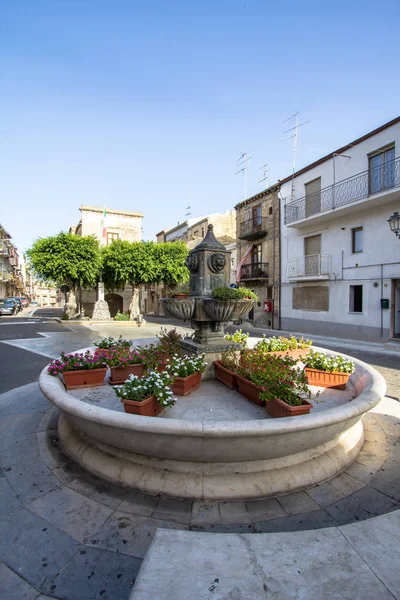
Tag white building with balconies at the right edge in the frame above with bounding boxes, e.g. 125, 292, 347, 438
280, 117, 400, 341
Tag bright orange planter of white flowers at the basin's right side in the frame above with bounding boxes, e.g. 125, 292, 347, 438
304, 352, 354, 390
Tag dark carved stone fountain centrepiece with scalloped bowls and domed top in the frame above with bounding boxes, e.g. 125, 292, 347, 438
161, 225, 253, 379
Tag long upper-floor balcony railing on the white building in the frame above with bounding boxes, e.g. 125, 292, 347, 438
285, 157, 400, 225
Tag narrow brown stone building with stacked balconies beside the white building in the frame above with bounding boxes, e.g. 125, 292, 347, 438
235, 185, 280, 329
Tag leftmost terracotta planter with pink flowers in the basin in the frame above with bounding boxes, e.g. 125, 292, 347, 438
47, 350, 107, 390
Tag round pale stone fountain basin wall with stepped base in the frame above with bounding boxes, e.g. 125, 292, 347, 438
39, 348, 386, 500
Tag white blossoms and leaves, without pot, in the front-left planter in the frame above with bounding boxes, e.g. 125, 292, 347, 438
114, 371, 176, 408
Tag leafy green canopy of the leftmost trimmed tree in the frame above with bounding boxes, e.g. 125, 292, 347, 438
26, 232, 101, 289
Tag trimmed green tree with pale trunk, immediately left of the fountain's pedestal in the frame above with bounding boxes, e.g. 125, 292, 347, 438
101, 240, 189, 321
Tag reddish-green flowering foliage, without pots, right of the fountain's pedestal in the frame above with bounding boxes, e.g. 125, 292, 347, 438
235, 350, 311, 406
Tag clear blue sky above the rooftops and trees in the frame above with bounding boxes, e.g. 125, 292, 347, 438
0, 0, 400, 250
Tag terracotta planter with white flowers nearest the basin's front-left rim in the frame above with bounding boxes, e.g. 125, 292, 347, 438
114, 371, 175, 417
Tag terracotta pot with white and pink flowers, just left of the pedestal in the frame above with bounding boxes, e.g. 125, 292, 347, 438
166, 354, 207, 396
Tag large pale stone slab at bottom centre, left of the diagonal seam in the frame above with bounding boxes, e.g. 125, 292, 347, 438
130, 528, 394, 600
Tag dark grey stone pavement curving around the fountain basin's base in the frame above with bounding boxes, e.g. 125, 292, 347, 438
0, 383, 400, 600
